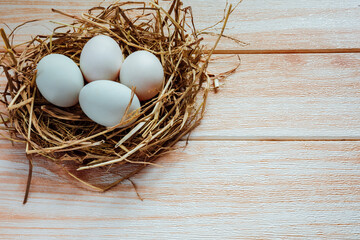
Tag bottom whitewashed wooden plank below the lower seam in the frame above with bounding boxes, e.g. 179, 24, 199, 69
0, 141, 360, 239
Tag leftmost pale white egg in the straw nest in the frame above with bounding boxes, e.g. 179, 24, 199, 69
36, 54, 84, 107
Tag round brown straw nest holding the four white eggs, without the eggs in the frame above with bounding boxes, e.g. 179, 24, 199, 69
1, 0, 233, 201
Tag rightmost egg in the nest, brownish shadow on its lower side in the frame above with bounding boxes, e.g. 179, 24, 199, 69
119, 51, 164, 101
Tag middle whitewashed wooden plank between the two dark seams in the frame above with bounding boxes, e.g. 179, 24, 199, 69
191, 54, 360, 140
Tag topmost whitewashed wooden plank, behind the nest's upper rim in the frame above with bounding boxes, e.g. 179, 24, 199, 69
0, 0, 360, 50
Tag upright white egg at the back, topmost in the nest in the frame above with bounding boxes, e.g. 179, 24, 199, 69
80, 35, 124, 82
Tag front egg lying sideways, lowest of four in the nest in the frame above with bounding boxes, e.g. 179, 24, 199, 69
79, 80, 140, 127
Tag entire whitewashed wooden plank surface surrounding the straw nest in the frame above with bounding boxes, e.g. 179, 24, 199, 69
0, 0, 360, 240
